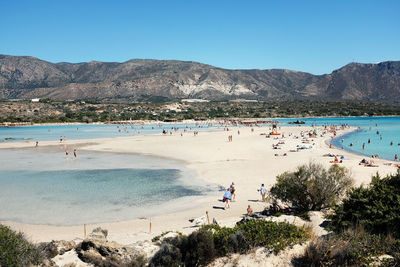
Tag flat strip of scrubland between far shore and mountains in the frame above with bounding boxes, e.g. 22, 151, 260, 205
0, 99, 400, 123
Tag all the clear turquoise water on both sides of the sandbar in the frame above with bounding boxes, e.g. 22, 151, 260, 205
0, 117, 400, 225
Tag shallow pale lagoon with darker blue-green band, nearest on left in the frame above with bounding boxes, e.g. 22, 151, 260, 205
0, 149, 218, 225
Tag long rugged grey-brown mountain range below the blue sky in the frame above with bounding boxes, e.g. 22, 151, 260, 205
0, 55, 400, 103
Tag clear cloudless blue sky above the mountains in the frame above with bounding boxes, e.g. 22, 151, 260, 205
0, 0, 400, 74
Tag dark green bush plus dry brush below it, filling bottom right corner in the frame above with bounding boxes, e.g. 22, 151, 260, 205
294, 171, 400, 266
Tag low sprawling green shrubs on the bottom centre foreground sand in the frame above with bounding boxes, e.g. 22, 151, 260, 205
150, 220, 310, 266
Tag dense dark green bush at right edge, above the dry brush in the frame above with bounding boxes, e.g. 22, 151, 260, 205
329, 171, 400, 238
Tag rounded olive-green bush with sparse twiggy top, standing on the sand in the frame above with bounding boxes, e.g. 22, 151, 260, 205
270, 163, 353, 211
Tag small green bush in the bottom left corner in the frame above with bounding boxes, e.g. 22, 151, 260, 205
0, 225, 41, 266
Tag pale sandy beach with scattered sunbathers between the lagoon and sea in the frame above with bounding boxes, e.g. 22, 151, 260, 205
0, 126, 396, 244
